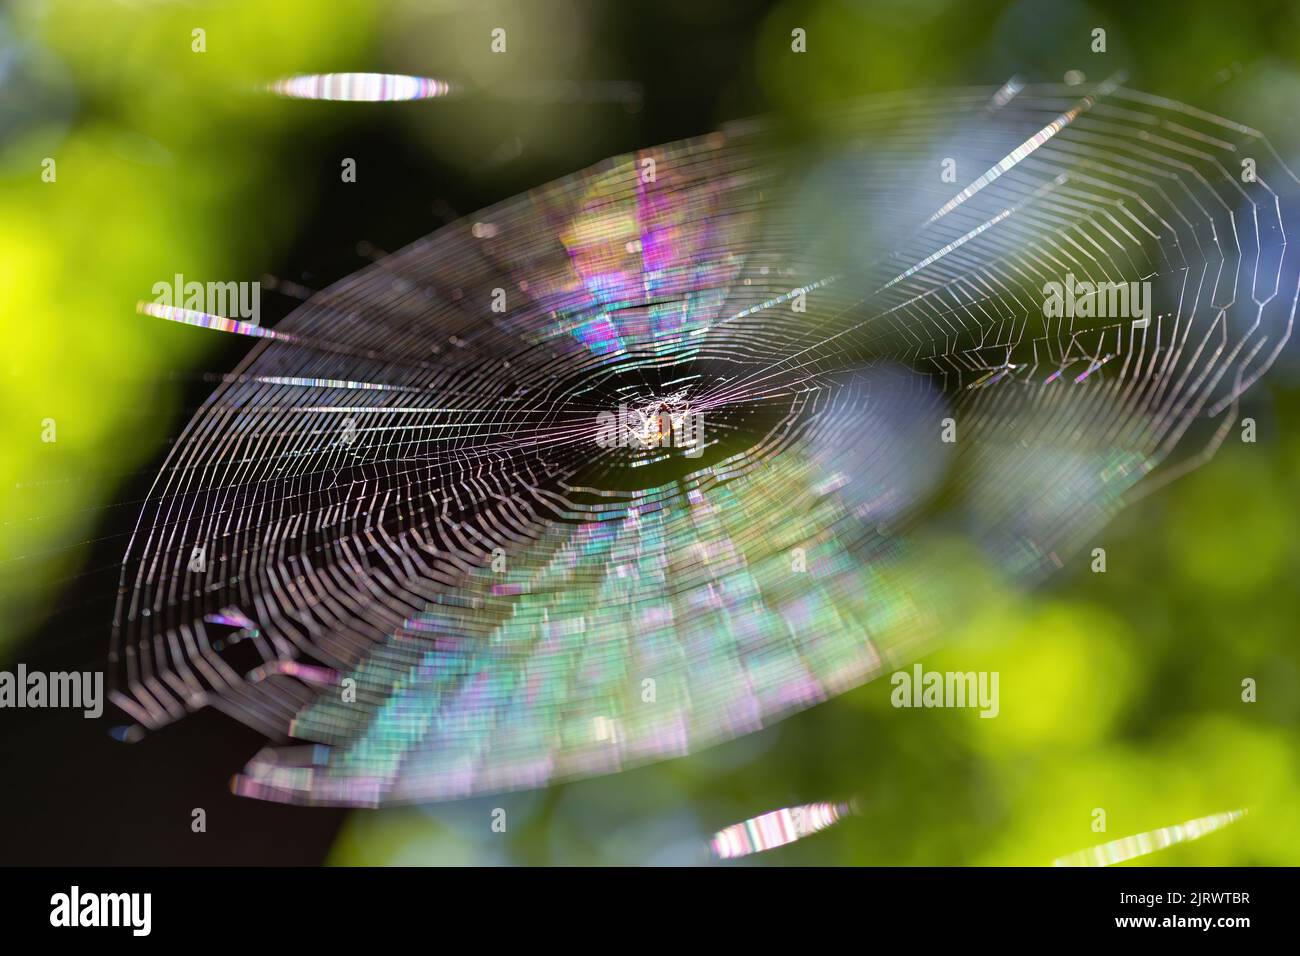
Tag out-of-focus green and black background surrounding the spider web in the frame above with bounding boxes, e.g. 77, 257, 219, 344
0, 0, 1300, 865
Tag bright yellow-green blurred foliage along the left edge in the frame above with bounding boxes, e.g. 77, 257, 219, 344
0, 0, 374, 639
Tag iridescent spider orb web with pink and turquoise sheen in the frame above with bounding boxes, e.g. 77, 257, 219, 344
112, 83, 1297, 805
